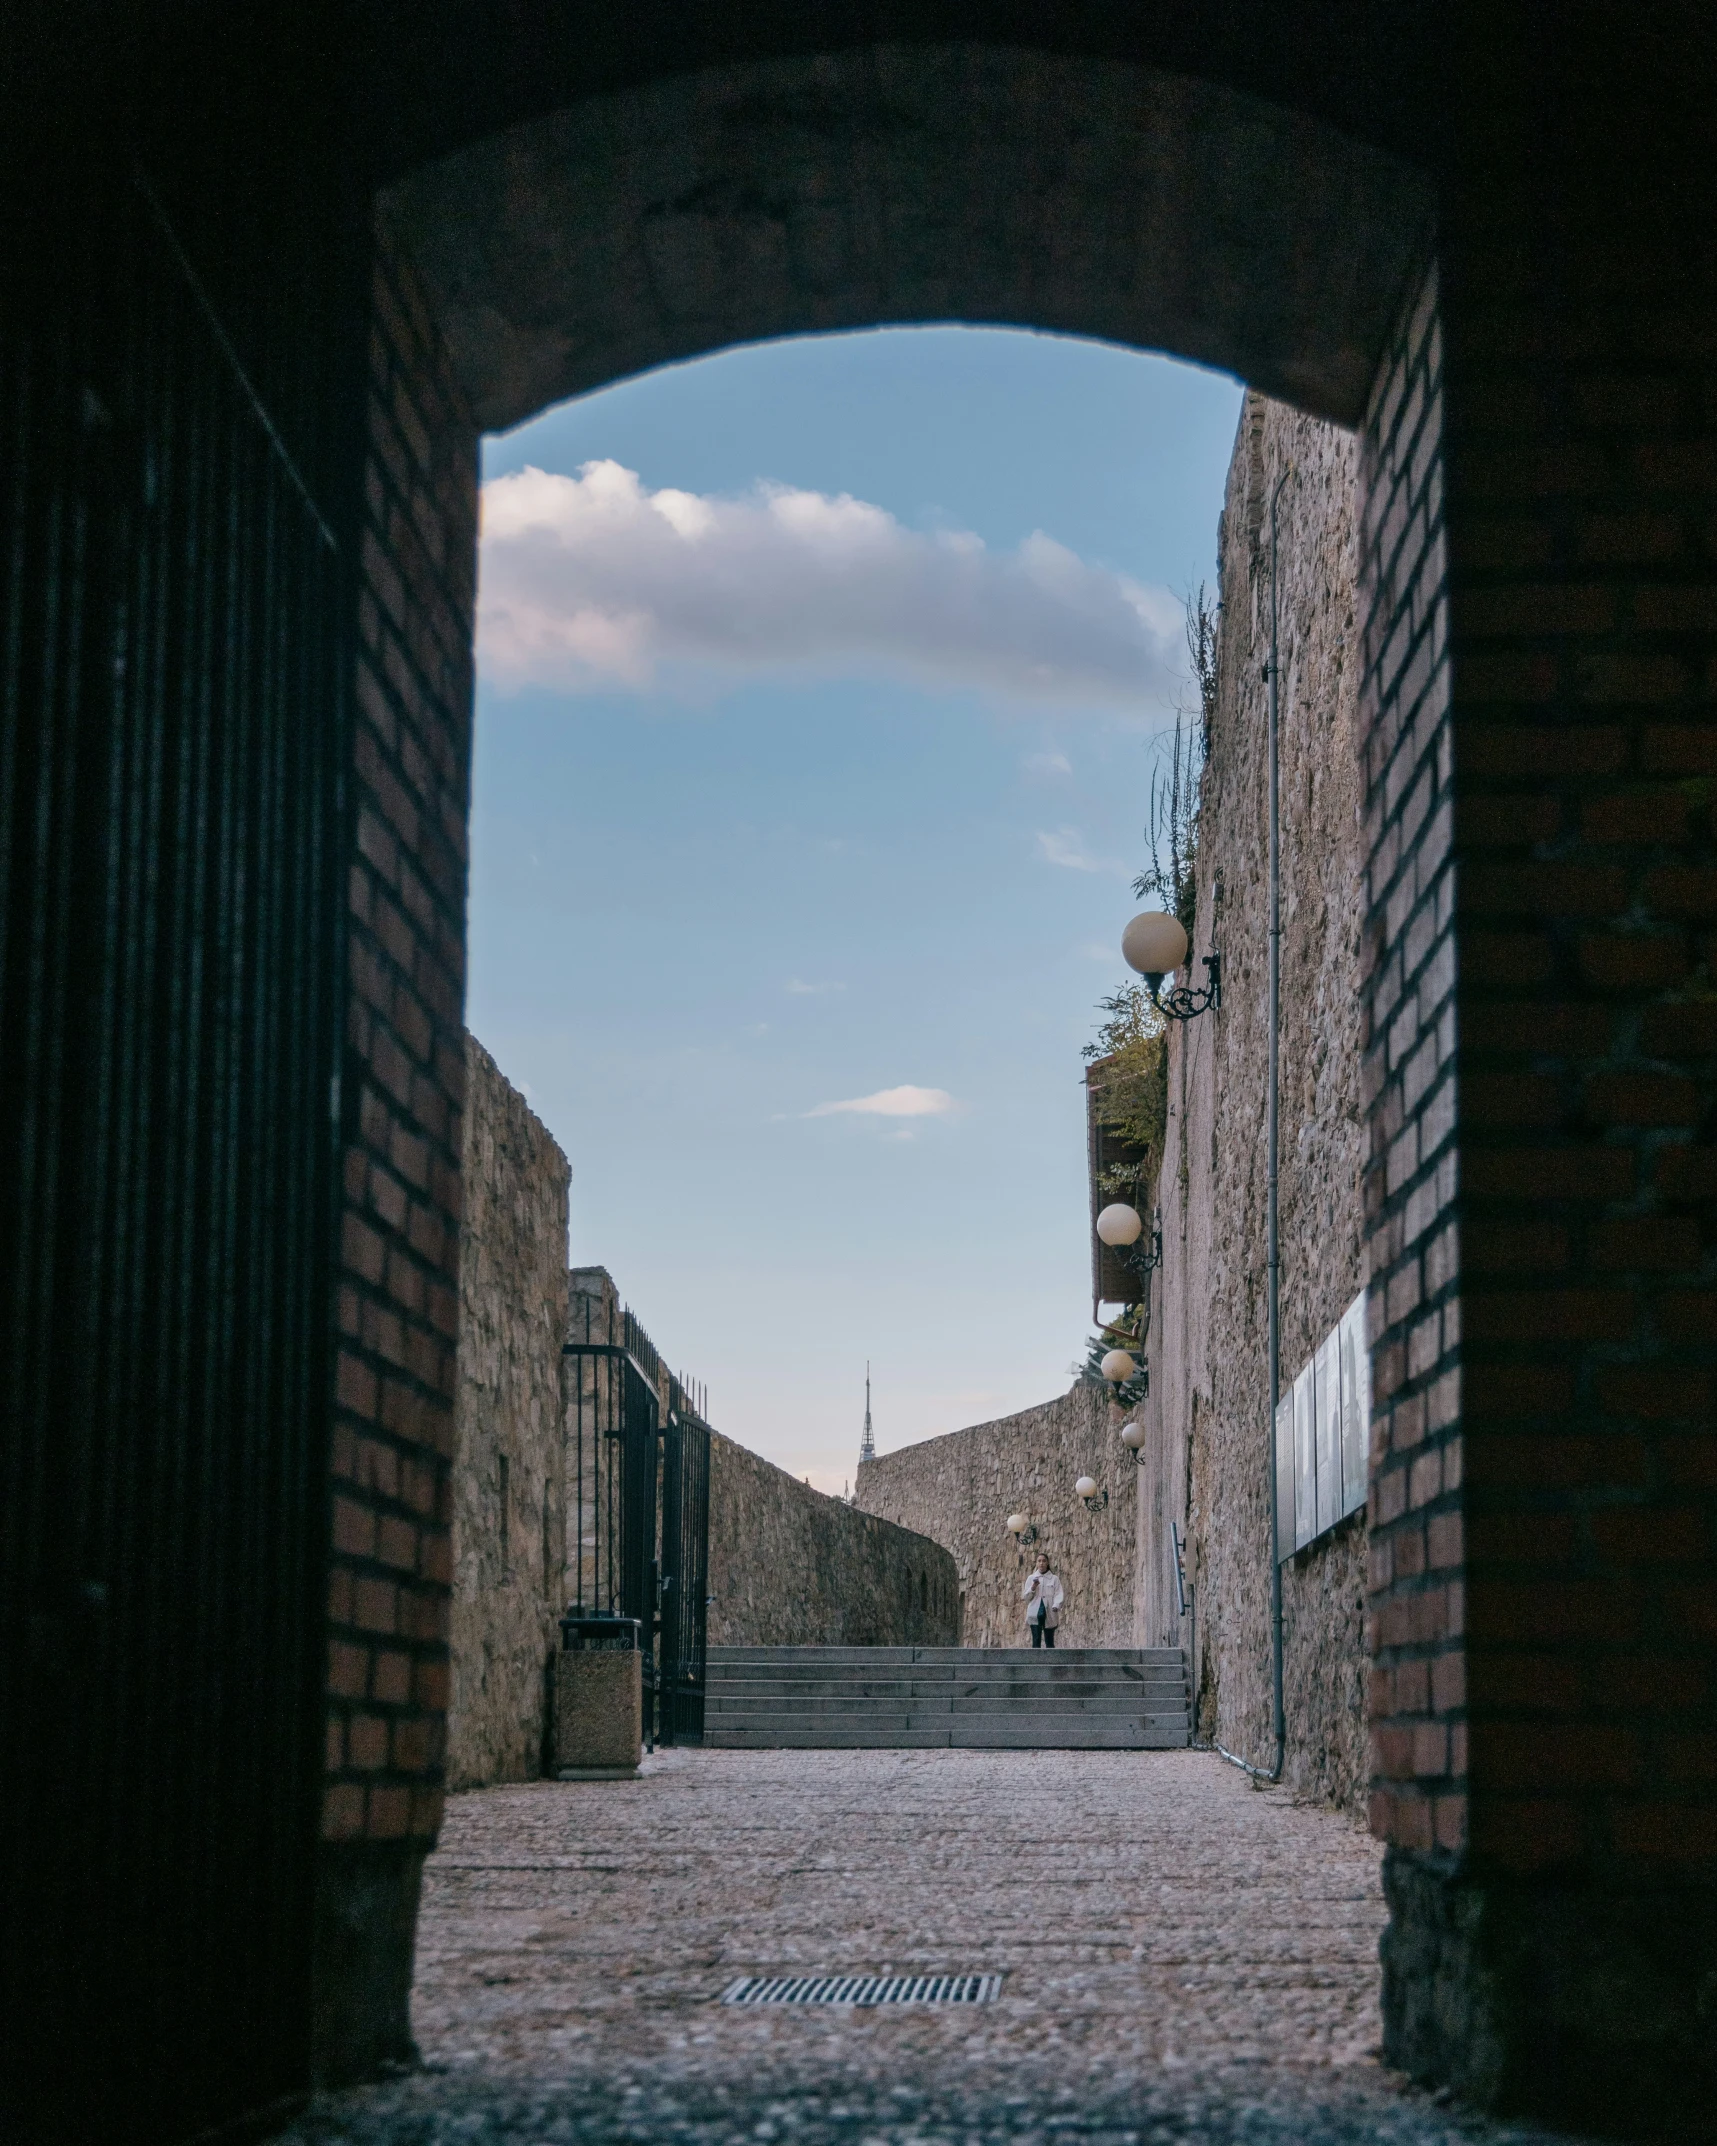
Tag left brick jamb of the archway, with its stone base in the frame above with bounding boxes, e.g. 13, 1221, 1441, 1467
315, 213, 476, 2082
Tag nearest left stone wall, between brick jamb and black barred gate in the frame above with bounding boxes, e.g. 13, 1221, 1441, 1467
446, 1037, 571, 1788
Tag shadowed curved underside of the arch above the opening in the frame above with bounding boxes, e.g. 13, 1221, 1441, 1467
384, 45, 1432, 429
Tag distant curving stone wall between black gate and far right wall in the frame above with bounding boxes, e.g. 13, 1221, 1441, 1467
708, 1434, 959, 1646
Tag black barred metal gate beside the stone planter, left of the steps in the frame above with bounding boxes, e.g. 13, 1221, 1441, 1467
564, 1296, 710, 1743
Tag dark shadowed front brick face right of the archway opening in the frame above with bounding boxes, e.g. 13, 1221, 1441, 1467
1449, 191, 1717, 1882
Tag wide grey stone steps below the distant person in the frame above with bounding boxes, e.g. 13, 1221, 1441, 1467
704, 1646, 1187, 1751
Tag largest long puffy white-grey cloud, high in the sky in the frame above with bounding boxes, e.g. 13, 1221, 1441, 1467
479, 461, 1180, 712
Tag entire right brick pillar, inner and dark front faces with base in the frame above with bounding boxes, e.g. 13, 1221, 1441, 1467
1367, 24, 1717, 2131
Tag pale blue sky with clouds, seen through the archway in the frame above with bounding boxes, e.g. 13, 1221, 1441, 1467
468, 328, 1241, 1489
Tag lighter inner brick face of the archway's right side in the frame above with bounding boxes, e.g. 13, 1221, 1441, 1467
1359, 275, 1466, 1852
